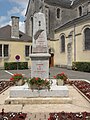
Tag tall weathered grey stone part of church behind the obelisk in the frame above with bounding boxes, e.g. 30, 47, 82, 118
25, 0, 90, 39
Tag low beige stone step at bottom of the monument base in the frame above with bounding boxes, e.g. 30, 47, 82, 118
5, 97, 72, 104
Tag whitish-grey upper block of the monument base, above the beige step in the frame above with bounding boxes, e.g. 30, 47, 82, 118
9, 84, 69, 98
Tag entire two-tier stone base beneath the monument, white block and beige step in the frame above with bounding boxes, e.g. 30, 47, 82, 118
5, 81, 72, 104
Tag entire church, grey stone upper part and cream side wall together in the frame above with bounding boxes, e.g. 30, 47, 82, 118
25, 0, 90, 68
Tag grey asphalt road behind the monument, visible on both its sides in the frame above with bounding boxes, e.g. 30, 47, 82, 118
0, 67, 90, 81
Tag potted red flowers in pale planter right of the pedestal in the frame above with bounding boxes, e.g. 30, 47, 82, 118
54, 72, 68, 85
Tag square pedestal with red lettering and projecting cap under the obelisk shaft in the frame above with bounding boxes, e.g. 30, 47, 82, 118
30, 53, 50, 79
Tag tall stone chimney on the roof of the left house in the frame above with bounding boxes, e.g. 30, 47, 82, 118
11, 16, 19, 39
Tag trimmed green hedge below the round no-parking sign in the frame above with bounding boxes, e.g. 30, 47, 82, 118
4, 62, 28, 70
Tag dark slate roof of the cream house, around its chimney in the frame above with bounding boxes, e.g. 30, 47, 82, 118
0, 25, 31, 42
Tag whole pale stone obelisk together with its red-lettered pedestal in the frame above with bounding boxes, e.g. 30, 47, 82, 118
30, 12, 50, 79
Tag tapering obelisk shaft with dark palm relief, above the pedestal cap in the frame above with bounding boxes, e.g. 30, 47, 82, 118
32, 12, 48, 53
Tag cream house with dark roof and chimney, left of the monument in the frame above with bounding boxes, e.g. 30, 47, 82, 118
0, 16, 32, 69
